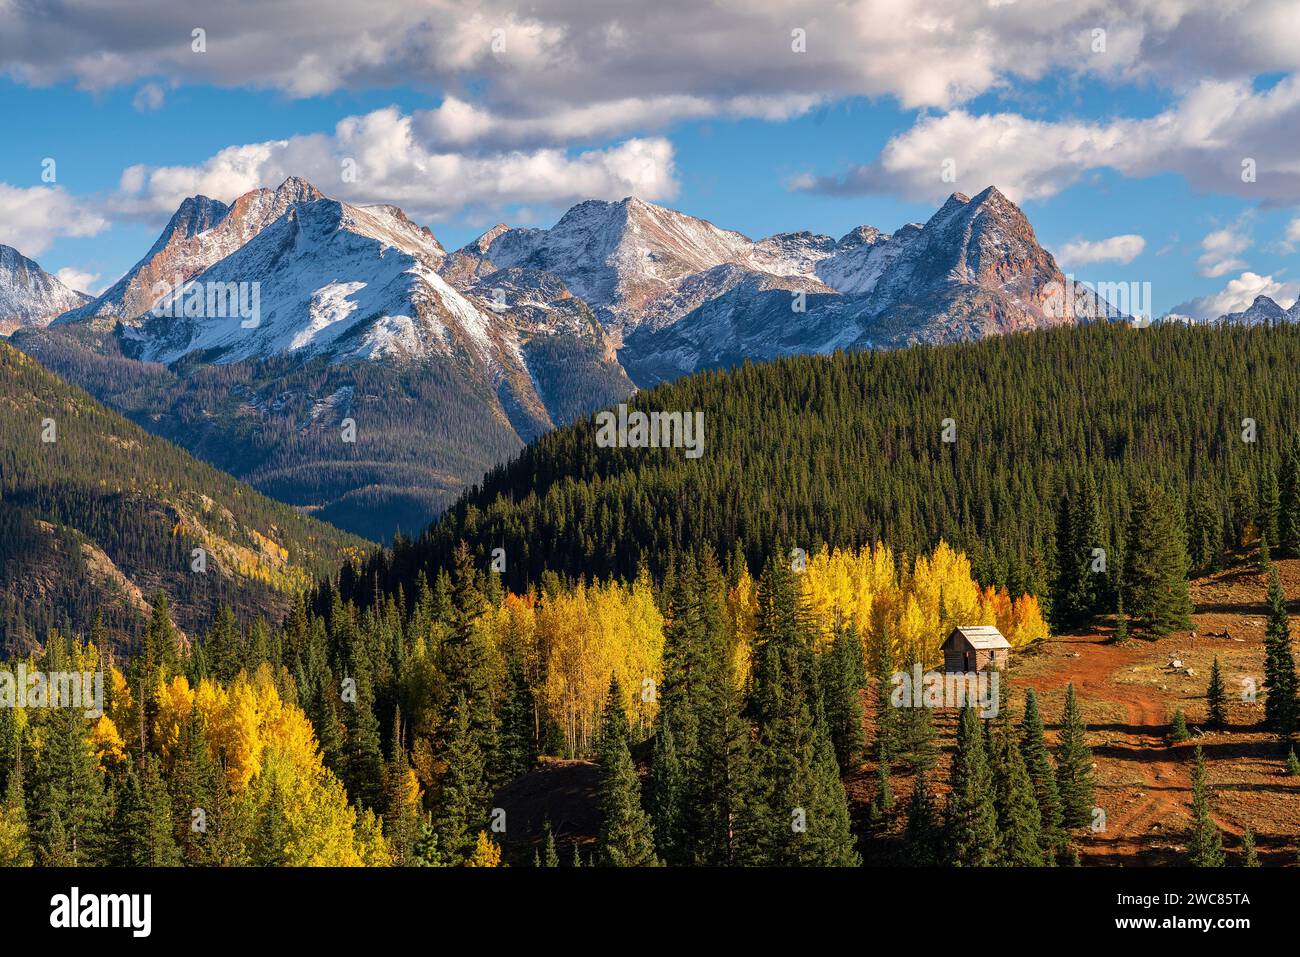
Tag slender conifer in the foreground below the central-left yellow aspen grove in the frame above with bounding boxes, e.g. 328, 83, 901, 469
598, 680, 659, 867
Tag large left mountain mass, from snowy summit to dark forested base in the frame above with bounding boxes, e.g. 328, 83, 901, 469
30, 178, 634, 540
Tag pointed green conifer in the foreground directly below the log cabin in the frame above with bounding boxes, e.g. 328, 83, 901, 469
944, 705, 1001, 867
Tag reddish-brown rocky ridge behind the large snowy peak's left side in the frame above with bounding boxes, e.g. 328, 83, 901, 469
57, 177, 321, 325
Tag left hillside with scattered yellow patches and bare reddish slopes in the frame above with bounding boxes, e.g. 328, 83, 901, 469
0, 345, 367, 653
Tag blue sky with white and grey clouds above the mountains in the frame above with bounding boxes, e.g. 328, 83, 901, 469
0, 0, 1300, 316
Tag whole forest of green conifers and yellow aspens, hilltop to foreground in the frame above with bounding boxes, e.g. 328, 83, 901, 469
0, 328, 1300, 866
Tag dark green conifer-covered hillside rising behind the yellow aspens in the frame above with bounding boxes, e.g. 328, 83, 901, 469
374, 324, 1300, 605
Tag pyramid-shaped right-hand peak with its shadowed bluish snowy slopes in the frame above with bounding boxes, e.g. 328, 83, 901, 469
619, 187, 1108, 385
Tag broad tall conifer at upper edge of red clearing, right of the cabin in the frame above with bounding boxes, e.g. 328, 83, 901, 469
1123, 481, 1192, 636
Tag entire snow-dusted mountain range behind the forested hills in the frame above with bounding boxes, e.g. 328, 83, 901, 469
0, 178, 1105, 538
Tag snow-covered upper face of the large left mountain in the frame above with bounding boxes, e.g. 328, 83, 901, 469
129, 199, 493, 364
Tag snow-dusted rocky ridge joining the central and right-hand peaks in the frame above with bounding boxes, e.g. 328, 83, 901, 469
446, 187, 1112, 386
